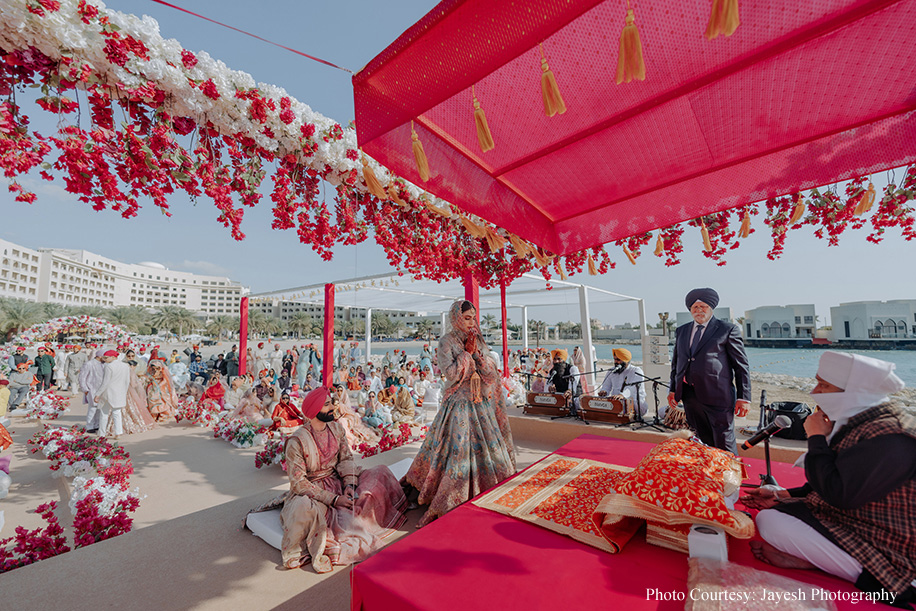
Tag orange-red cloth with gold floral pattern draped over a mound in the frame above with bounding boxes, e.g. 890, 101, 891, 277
614, 439, 741, 527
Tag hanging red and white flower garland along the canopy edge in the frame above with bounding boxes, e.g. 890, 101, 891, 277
0, 0, 914, 288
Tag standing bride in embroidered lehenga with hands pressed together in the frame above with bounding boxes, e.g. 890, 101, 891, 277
404, 301, 515, 526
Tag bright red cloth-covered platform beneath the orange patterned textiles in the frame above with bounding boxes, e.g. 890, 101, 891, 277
351, 435, 873, 611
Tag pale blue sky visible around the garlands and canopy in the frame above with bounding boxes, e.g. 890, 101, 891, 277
0, 0, 916, 323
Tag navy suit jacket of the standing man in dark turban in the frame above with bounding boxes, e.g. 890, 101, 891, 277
671, 318, 751, 408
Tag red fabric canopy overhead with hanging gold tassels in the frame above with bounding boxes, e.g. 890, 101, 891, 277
353, 0, 916, 254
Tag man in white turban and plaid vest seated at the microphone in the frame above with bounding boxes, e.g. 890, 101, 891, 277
741, 351, 916, 603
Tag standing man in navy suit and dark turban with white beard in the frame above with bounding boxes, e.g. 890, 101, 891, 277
668, 288, 751, 454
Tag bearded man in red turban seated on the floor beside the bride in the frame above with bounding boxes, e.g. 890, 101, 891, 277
270, 386, 407, 573
